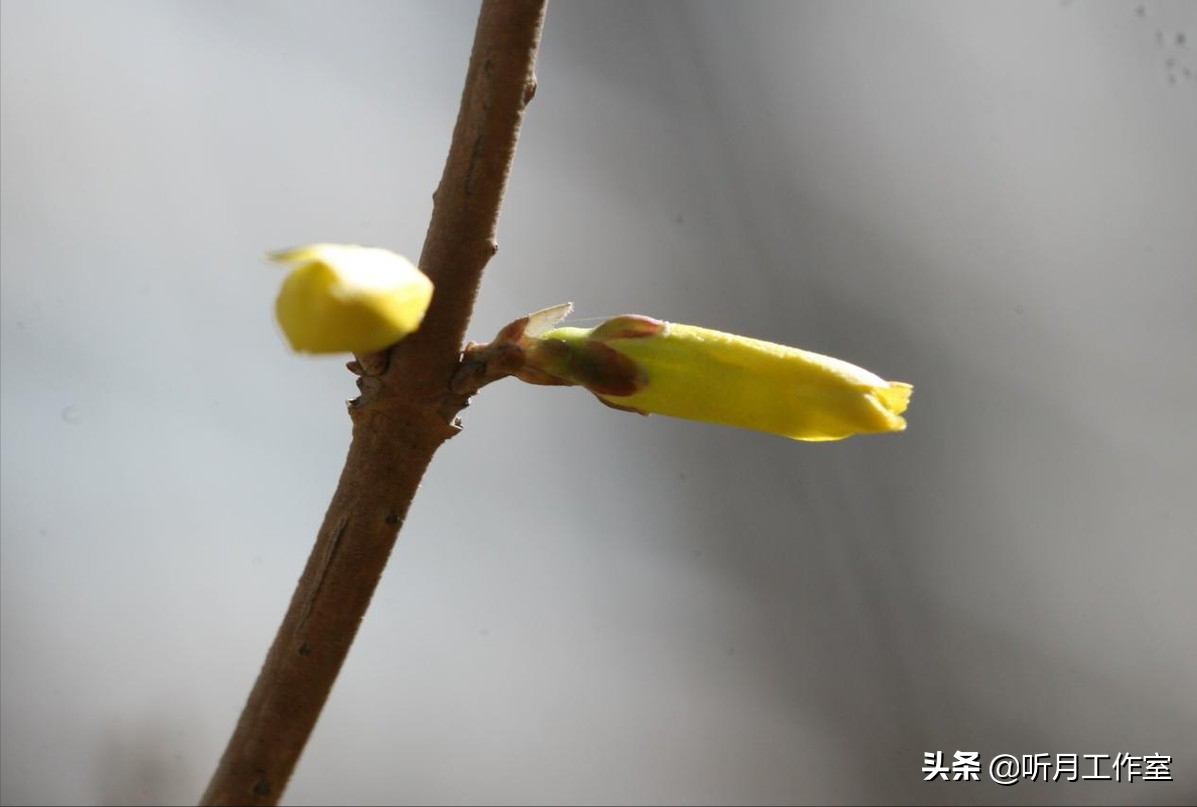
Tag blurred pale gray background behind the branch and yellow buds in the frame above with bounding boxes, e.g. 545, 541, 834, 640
0, 0, 1197, 805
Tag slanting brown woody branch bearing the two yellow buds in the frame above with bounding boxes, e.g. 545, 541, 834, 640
200, 0, 547, 805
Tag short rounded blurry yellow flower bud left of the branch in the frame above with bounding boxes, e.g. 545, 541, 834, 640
269, 244, 432, 353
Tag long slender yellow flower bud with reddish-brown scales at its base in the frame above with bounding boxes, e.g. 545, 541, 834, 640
483, 305, 912, 441
